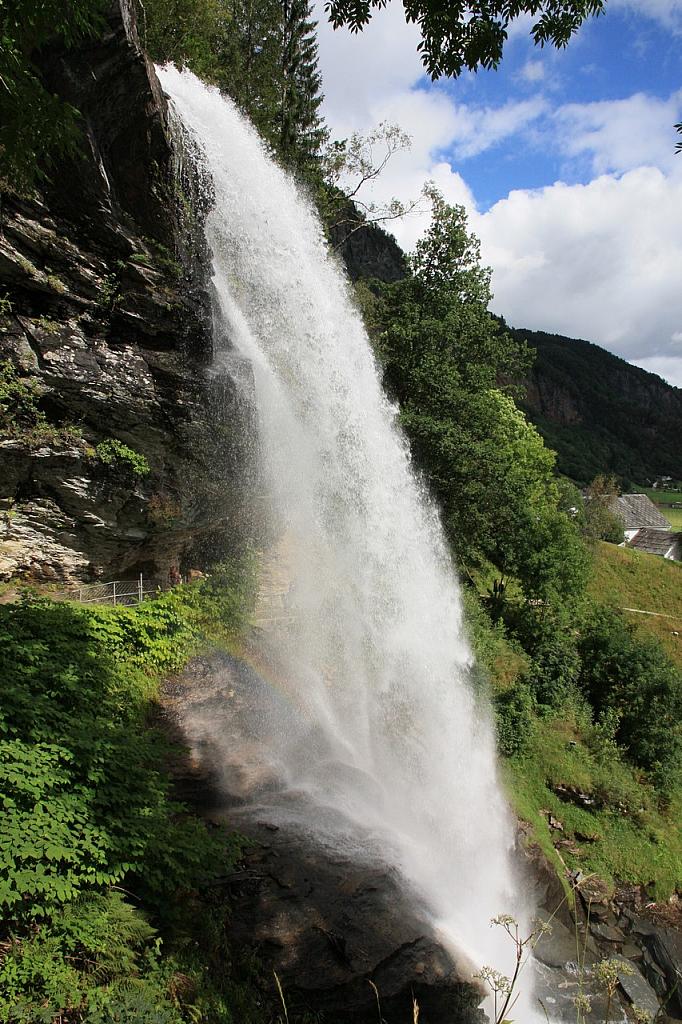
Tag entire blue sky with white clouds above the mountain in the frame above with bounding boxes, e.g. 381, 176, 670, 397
317, 0, 682, 386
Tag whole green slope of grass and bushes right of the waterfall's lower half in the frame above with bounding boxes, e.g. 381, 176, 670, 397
466, 544, 682, 899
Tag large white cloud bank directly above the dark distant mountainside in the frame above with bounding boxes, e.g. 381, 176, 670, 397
472, 168, 682, 371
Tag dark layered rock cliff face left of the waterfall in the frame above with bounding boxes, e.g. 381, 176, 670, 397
0, 0, 250, 584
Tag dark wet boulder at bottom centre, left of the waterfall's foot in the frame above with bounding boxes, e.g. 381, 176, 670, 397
225, 822, 485, 1024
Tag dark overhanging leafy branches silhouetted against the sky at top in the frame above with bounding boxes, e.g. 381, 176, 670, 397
325, 0, 605, 79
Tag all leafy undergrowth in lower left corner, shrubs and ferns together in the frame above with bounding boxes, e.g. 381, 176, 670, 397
0, 566, 260, 1024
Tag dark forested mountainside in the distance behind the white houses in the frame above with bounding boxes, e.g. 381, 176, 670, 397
512, 329, 682, 489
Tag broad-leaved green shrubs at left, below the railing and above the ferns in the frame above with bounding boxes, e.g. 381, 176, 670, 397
0, 601, 220, 925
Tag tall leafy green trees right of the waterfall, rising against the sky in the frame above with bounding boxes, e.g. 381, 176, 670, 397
368, 194, 585, 599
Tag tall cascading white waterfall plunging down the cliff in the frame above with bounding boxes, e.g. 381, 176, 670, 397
160, 68, 531, 1021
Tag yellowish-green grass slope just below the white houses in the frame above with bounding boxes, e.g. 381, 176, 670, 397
589, 542, 682, 667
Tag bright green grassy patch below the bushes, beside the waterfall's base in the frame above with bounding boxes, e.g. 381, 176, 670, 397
503, 709, 682, 900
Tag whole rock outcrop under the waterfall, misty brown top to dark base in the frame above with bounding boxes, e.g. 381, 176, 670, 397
164, 650, 486, 1024
